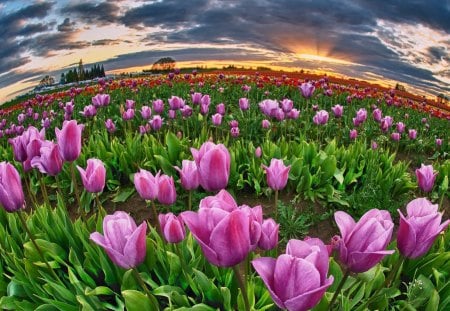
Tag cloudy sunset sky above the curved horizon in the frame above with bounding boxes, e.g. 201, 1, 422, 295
0, 0, 450, 103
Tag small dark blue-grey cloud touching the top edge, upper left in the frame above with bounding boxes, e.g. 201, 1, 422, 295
62, 1, 119, 25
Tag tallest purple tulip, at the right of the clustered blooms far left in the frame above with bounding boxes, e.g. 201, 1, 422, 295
55, 120, 84, 162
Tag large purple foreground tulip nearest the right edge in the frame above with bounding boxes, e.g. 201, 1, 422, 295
397, 198, 450, 258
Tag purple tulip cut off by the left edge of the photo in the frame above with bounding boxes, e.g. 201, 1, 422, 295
0, 161, 25, 213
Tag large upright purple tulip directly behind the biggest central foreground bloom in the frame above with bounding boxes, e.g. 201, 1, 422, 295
191, 142, 231, 191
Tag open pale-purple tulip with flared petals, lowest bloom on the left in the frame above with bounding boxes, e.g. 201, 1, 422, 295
90, 211, 147, 269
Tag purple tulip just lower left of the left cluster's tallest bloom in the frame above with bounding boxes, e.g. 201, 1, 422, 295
30, 141, 63, 176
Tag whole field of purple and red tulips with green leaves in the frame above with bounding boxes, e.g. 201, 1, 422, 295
0, 72, 450, 311
